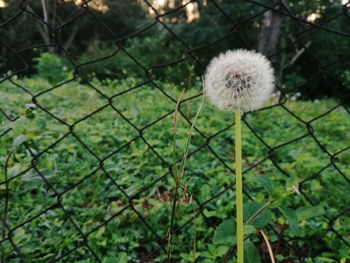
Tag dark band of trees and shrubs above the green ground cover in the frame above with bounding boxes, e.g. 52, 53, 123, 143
0, 0, 350, 99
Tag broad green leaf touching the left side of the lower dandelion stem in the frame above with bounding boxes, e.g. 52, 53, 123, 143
213, 219, 236, 245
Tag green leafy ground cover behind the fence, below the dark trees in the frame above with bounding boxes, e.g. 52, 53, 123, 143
0, 79, 350, 263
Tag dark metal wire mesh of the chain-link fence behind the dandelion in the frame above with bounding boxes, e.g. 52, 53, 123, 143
0, 0, 350, 262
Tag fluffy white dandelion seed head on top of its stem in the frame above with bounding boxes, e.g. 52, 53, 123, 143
203, 49, 275, 112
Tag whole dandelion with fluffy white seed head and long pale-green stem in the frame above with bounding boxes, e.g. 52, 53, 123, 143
203, 49, 275, 263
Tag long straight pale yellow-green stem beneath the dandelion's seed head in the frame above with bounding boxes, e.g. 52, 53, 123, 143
235, 110, 244, 263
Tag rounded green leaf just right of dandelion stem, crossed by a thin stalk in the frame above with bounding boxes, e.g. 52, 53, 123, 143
244, 202, 272, 229
